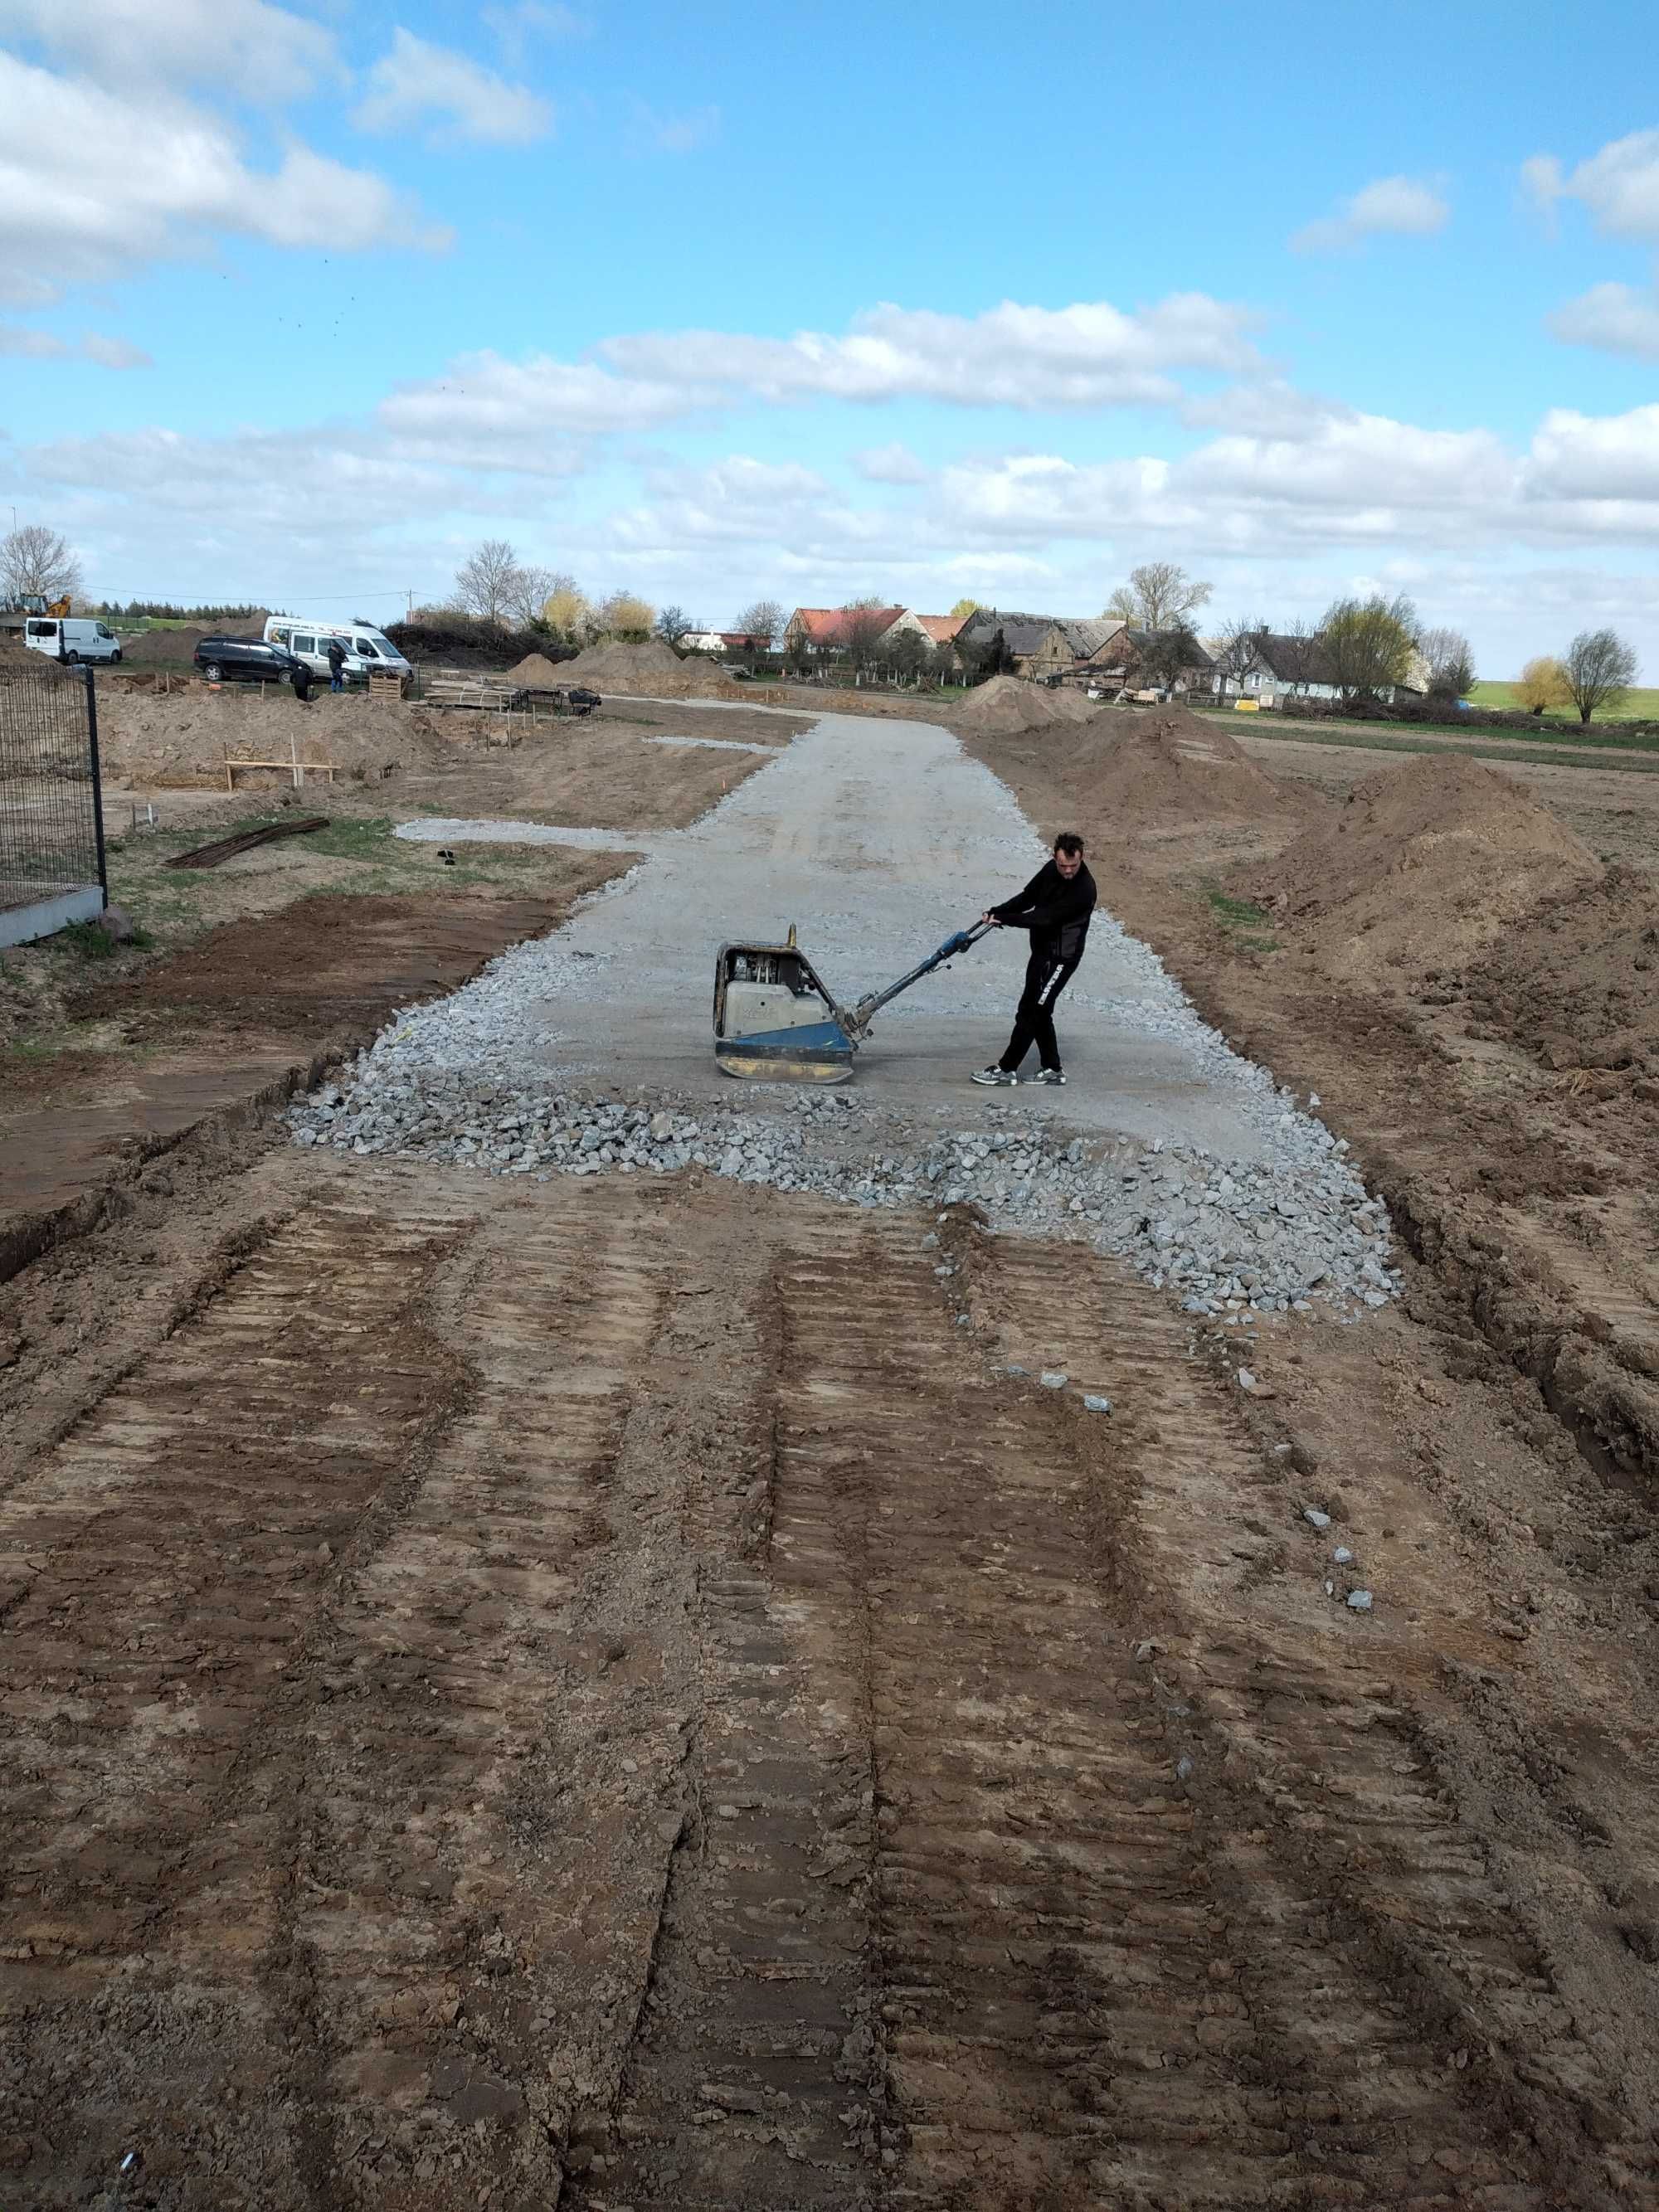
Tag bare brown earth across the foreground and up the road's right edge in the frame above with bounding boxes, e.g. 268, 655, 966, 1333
0, 694, 1659, 2212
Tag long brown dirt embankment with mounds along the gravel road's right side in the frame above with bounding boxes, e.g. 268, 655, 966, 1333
965, 732, 1659, 1495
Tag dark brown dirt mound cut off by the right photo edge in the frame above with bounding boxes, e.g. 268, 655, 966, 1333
1457, 867, 1659, 1068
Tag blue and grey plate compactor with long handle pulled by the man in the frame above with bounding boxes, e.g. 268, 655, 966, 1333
714, 922, 995, 1084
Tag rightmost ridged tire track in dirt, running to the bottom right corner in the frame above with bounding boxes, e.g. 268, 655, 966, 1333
953, 1232, 1655, 2205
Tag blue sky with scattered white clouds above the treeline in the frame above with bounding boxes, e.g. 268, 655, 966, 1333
0, 0, 1659, 681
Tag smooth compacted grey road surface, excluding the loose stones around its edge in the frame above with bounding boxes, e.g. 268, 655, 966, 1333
393, 706, 1281, 1159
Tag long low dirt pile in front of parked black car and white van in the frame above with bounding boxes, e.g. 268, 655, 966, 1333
97, 690, 454, 790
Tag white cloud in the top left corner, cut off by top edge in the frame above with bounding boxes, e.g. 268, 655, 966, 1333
0, 0, 345, 106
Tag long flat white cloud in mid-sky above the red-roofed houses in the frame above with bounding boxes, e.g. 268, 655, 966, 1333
600, 292, 1257, 409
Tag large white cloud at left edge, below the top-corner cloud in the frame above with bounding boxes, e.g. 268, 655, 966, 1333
0, 53, 442, 305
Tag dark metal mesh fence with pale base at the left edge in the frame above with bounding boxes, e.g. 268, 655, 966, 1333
0, 661, 109, 945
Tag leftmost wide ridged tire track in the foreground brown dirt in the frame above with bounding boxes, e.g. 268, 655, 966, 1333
0, 1201, 479, 2205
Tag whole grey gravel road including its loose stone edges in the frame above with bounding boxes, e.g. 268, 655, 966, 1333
294, 714, 1398, 1319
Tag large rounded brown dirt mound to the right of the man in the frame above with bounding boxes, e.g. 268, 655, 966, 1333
1252, 754, 1602, 984
